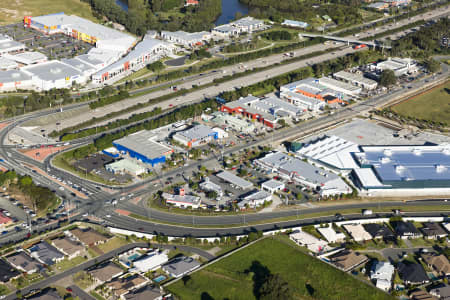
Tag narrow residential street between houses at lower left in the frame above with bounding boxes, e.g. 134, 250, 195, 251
5, 243, 148, 300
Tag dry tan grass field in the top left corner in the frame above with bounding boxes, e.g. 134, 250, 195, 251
0, 0, 96, 25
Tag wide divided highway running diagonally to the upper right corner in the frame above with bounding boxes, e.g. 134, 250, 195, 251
25, 6, 450, 136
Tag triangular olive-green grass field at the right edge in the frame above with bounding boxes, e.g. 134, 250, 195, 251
392, 81, 450, 123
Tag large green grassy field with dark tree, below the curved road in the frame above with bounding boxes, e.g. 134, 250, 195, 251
167, 236, 394, 300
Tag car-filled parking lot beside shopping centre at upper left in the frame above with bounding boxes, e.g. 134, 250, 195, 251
0, 23, 93, 60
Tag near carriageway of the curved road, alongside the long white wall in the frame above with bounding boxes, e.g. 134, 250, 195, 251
102, 207, 446, 238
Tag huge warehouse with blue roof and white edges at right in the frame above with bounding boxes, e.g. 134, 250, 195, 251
353, 144, 450, 191
